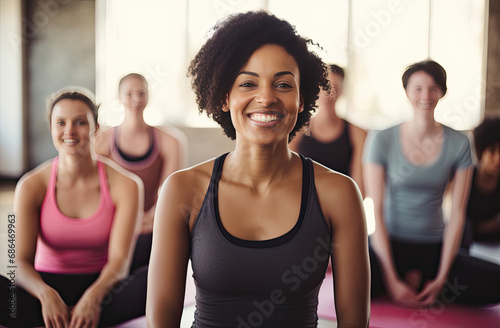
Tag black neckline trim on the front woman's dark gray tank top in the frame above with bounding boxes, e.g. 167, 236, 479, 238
211, 153, 313, 248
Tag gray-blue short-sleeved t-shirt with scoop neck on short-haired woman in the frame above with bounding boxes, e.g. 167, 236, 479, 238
363, 125, 472, 243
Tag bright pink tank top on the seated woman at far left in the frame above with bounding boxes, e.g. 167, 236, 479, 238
35, 157, 115, 274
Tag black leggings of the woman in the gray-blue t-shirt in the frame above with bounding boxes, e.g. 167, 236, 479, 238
370, 240, 500, 305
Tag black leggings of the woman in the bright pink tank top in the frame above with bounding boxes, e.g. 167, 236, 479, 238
0, 267, 148, 328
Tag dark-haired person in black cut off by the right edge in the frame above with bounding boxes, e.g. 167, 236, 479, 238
467, 117, 500, 242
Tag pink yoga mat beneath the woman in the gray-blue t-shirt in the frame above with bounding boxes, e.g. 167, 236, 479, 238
318, 272, 500, 328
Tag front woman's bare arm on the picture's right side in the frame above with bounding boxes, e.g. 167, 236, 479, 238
315, 168, 370, 328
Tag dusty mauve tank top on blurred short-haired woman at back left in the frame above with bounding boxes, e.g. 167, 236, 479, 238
109, 127, 163, 211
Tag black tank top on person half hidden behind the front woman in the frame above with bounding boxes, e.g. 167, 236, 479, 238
298, 120, 353, 175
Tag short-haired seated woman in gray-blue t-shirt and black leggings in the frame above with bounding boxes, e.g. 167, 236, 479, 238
364, 61, 500, 307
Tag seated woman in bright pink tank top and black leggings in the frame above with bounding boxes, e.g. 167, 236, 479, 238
0, 91, 147, 327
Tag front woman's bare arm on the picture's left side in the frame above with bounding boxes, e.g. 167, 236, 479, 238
146, 171, 193, 328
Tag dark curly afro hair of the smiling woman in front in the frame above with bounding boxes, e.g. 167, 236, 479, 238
188, 11, 330, 140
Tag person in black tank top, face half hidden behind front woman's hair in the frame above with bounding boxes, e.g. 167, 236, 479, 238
290, 64, 366, 195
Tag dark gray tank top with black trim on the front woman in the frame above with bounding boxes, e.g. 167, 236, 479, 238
191, 154, 333, 328
